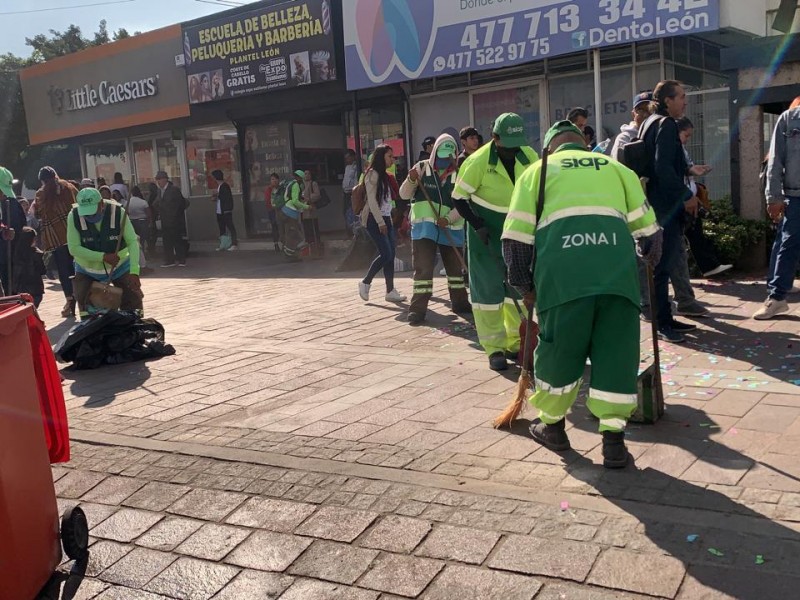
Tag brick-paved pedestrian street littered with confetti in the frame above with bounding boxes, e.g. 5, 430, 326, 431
34, 253, 800, 600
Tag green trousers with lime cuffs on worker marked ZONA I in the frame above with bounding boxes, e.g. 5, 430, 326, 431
530, 295, 639, 431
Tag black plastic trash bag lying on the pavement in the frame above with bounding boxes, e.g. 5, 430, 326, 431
53, 310, 175, 369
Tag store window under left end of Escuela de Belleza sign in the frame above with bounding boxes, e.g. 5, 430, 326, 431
186, 125, 242, 196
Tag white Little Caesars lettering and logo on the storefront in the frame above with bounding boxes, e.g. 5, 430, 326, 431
48, 75, 159, 115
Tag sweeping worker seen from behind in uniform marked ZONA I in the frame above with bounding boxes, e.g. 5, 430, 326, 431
503, 121, 661, 468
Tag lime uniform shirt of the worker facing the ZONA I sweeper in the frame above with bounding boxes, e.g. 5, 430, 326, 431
453, 142, 539, 214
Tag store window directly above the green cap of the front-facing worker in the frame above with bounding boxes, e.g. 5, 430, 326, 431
472, 84, 541, 150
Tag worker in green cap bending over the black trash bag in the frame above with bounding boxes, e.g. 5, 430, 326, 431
67, 188, 144, 319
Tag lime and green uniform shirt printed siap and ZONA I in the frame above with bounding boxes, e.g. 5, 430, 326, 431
502, 149, 658, 311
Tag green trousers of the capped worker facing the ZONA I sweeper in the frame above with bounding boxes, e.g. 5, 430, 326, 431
467, 204, 521, 356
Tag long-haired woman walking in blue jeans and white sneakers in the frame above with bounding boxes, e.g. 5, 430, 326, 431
358, 145, 406, 302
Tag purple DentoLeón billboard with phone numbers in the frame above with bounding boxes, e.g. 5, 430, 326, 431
344, 0, 720, 90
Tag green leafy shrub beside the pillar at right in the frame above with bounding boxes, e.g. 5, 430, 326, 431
703, 196, 772, 263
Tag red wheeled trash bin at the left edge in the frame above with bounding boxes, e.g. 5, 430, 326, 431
0, 298, 88, 600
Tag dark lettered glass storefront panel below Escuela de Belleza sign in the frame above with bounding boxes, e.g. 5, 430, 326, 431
244, 121, 292, 235
